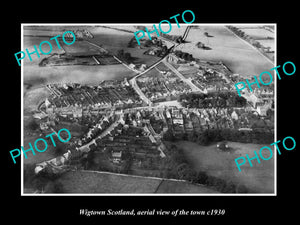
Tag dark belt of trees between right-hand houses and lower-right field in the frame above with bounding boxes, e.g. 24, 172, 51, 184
163, 129, 274, 145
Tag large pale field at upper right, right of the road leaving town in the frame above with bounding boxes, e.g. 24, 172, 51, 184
177, 26, 274, 76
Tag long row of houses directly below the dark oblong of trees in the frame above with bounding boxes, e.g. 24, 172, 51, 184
116, 107, 274, 136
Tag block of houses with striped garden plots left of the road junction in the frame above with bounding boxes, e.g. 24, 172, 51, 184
45, 82, 143, 117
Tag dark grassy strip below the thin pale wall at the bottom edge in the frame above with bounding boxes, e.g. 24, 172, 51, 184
53, 171, 216, 194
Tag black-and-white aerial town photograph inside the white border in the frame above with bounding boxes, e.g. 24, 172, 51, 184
21, 24, 276, 195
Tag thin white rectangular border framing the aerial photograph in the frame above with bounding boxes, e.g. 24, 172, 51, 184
21, 23, 277, 196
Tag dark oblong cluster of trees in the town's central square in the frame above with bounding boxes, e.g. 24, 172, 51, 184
178, 92, 247, 108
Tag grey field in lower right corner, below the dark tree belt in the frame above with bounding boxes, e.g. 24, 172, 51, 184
176, 141, 274, 193
